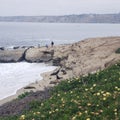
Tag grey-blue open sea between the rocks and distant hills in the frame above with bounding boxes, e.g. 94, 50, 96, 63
0, 22, 120, 47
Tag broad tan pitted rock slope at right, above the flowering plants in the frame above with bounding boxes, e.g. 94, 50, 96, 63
54, 37, 120, 76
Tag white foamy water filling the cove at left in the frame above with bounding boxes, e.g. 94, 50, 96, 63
0, 62, 56, 100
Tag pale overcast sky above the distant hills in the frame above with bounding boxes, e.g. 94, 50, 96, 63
0, 0, 120, 16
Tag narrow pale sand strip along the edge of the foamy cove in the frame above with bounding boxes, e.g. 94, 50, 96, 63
0, 67, 57, 106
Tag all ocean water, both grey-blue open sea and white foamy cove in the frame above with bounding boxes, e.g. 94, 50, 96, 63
0, 22, 120, 100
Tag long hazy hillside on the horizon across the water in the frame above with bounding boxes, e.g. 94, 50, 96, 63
0, 13, 120, 23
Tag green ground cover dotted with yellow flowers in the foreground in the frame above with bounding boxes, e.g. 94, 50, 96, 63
0, 63, 120, 120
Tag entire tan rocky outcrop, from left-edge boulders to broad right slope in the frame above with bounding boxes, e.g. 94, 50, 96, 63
0, 37, 120, 77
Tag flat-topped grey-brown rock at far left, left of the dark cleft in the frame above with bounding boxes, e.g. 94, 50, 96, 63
0, 49, 25, 63
